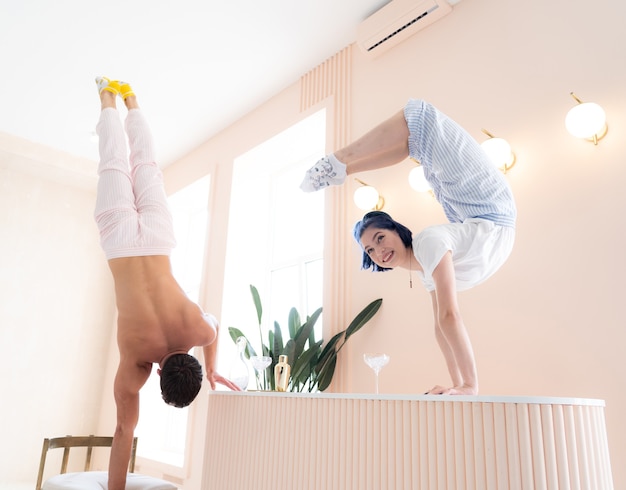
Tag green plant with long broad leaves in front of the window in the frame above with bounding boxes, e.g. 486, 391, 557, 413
228, 285, 383, 392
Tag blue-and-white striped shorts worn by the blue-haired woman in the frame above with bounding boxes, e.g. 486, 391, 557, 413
404, 99, 517, 228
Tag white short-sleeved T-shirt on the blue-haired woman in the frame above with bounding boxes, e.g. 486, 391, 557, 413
413, 218, 515, 291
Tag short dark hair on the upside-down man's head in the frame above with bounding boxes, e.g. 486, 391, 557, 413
161, 354, 202, 408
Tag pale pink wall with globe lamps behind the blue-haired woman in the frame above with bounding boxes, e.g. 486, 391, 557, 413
166, 0, 626, 488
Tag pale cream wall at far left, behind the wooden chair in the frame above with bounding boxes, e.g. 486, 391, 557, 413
0, 135, 114, 488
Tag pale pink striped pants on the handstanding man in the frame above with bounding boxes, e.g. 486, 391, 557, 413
94, 108, 176, 259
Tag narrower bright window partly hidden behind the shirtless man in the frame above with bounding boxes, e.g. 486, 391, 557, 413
135, 176, 211, 468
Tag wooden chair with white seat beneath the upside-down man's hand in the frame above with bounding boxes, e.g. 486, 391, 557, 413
35, 435, 178, 490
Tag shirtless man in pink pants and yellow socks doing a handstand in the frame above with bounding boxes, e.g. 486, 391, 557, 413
94, 77, 239, 490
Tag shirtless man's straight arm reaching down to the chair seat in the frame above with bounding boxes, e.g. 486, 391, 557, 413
109, 361, 152, 490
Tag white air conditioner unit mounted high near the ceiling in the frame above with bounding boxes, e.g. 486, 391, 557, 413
357, 0, 458, 56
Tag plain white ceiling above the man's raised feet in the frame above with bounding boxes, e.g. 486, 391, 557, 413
0, 0, 389, 166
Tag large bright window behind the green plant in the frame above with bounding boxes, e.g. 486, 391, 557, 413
218, 111, 326, 379
